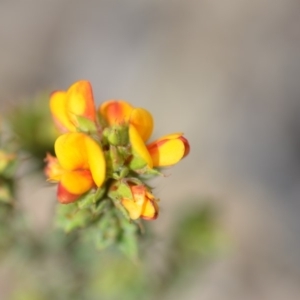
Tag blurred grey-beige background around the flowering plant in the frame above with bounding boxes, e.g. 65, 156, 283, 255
0, 0, 300, 300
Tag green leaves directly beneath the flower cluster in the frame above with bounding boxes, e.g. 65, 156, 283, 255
56, 189, 139, 260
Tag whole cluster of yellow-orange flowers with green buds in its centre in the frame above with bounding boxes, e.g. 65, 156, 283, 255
45, 80, 190, 220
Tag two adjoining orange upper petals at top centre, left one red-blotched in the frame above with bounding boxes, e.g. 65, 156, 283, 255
99, 100, 153, 142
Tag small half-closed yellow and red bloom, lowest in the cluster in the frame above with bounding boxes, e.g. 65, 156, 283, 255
121, 185, 159, 220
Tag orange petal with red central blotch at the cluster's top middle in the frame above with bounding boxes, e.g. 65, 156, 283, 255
100, 100, 133, 125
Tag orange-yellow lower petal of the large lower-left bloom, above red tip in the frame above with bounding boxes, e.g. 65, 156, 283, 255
60, 170, 95, 195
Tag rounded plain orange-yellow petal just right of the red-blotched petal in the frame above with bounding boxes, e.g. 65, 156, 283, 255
129, 108, 154, 142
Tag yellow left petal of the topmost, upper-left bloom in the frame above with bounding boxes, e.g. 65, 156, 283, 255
50, 91, 76, 132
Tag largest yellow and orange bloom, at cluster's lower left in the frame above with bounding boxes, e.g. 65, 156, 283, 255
45, 132, 106, 203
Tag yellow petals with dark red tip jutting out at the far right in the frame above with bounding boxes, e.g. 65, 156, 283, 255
147, 133, 190, 167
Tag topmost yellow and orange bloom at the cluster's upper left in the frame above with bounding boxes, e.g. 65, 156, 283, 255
50, 80, 96, 133
